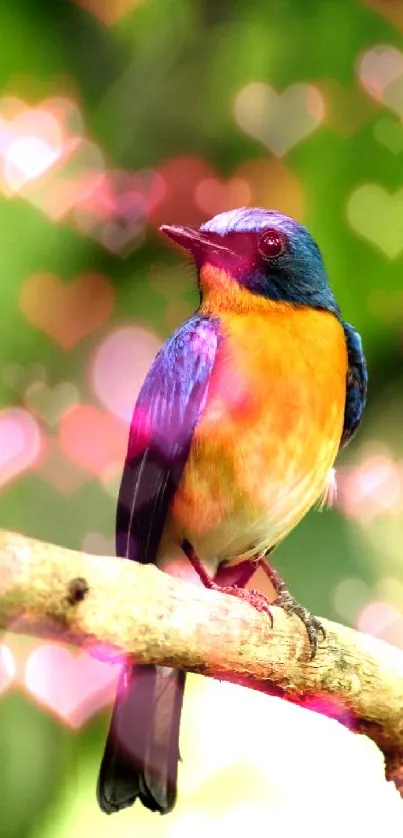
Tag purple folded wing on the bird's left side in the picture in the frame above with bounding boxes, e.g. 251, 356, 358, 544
116, 314, 219, 564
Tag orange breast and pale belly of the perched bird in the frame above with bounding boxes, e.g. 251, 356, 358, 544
164, 302, 347, 559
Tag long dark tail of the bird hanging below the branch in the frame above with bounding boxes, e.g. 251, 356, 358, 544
97, 665, 185, 814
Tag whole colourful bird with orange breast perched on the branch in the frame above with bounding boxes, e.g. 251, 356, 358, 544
97, 207, 368, 814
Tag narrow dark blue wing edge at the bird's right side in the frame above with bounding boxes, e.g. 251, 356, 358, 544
340, 323, 368, 448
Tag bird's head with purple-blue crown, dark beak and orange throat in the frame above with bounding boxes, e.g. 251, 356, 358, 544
161, 207, 339, 315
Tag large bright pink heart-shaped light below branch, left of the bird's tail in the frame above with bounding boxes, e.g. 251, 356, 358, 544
24, 643, 121, 728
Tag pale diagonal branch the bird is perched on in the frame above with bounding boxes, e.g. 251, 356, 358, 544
0, 531, 403, 793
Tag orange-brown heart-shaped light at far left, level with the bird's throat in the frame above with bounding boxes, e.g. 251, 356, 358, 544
20, 273, 114, 349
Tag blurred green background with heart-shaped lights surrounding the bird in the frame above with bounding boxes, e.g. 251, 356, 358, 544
0, 0, 403, 838
